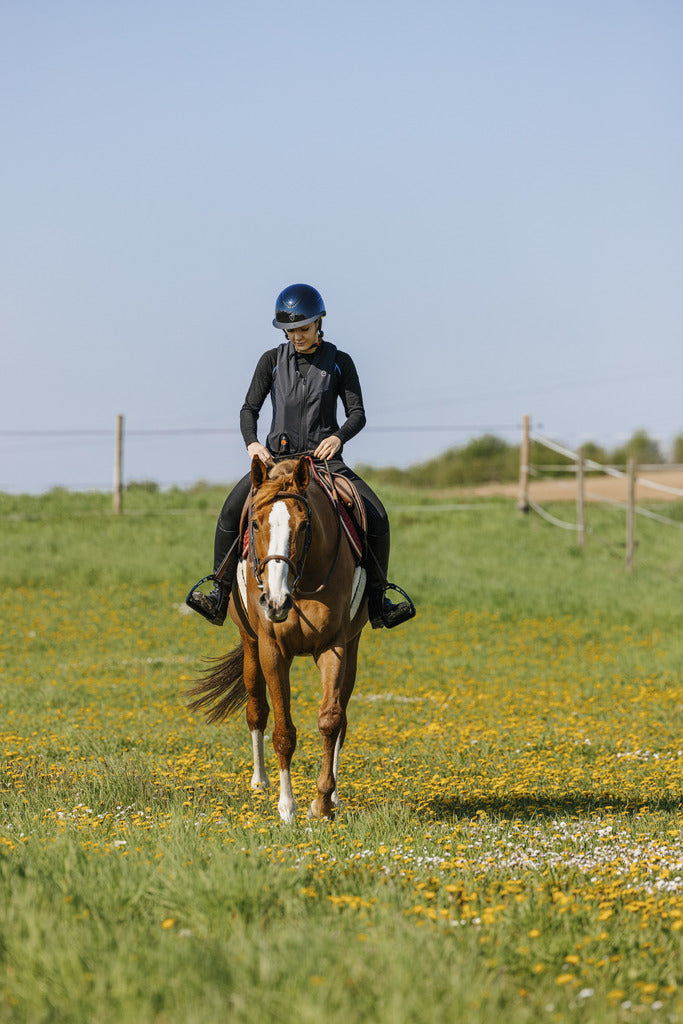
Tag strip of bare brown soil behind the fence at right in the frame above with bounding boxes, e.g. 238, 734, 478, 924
467, 469, 683, 503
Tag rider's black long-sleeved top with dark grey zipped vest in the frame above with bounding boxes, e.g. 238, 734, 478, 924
240, 341, 366, 454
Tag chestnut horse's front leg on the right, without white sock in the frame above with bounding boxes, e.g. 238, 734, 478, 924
310, 640, 346, 818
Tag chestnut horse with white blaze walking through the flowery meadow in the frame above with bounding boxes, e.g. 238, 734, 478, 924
185, 457, 368, 822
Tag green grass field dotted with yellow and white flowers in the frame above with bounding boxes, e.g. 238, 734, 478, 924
0, 489, 683, 1024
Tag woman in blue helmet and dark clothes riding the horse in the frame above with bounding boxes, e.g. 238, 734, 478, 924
187, 285, 415, 629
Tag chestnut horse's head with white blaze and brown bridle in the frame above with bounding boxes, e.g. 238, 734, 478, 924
249, 457, 310, 623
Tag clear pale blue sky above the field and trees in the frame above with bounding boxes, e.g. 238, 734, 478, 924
0, 0, 683, 492
